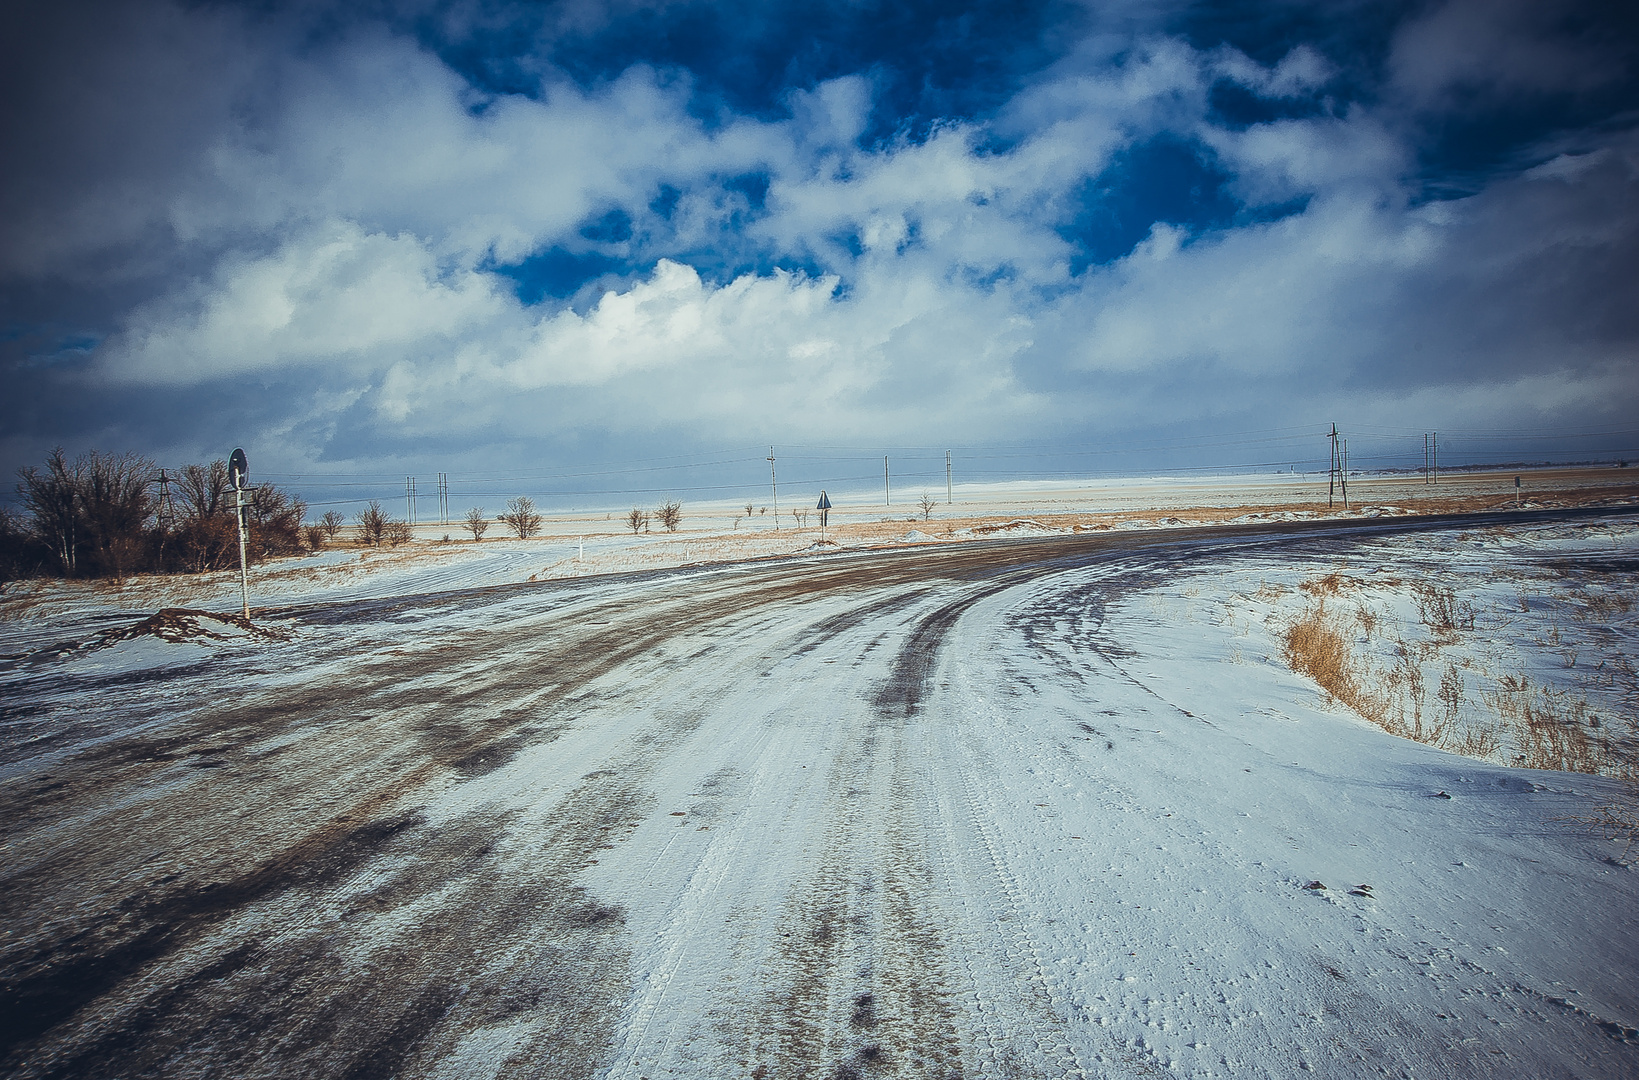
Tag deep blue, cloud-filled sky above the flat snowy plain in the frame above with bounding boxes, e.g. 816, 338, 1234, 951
0, 0, 1639, 505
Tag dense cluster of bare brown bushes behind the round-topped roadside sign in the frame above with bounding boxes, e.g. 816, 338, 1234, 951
0, 449, 308, 582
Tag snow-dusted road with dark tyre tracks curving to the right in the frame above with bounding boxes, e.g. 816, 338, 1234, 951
0, 515, 1634, 1077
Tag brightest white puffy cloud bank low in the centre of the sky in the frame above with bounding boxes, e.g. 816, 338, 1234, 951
342, 261, 1042, 438
